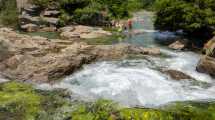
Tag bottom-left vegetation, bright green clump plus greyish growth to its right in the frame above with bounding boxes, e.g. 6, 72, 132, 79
0, 82, 73, 120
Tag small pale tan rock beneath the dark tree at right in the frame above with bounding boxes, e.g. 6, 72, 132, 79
169, 40, 187, 50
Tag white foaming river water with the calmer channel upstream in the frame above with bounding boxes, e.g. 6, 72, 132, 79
41, 12, 215, 107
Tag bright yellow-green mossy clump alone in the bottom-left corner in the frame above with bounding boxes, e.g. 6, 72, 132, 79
0, 82, 41, 120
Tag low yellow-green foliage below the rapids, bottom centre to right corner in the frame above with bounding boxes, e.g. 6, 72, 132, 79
72, 100, 215, 120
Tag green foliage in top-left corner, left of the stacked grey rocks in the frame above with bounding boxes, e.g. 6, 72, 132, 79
0, 0, 18, 27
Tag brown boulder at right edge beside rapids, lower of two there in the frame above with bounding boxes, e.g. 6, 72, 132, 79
196, 56, 215, 77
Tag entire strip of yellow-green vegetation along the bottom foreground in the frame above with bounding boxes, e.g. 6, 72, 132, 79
0, 82, 215, 120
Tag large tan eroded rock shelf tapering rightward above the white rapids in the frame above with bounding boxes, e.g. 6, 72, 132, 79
0, 28, 160, 83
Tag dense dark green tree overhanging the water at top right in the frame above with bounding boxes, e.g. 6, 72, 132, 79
155, 0, 215, 35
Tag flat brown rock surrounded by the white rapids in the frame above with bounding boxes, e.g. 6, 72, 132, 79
162, 70, 194, 80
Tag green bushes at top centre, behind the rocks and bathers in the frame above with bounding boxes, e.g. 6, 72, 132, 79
33, 0, 141, 25
